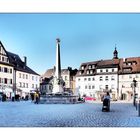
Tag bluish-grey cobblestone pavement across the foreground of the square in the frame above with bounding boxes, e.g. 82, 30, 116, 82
0, 101, 140, 127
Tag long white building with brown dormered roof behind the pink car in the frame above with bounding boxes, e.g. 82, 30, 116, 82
76, 59, 118, 99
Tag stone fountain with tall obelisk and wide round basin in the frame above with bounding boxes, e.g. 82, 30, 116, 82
40, 38, 78, 104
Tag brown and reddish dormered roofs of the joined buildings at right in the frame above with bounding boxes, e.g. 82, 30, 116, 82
76, 57, 140, 76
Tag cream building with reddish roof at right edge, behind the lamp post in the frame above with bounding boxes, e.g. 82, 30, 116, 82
119, 57, 140, 100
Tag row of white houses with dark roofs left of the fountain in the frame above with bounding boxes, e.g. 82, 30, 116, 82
0, 42, 40, 97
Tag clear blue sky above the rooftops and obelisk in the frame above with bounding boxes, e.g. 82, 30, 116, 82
0, 13, 140, 74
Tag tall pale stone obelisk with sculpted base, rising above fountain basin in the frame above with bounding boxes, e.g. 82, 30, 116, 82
53, 38, 64, 94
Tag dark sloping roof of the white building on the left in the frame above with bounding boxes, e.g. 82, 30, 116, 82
7, 52, 39, 75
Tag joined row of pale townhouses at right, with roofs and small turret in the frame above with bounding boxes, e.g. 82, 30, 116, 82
76, 48, 140, 100
